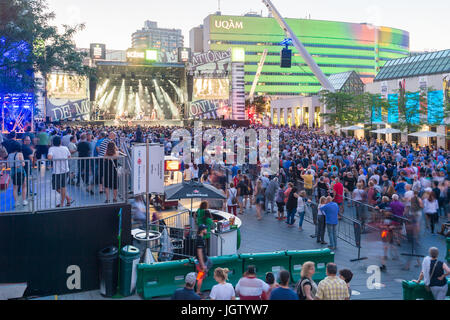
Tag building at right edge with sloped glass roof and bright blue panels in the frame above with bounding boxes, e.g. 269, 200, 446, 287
365, 49, 450, 148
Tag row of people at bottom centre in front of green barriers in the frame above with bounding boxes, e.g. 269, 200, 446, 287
172, 225, 353, 300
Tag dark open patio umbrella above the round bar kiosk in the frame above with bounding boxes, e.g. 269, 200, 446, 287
165, 180, 226, 212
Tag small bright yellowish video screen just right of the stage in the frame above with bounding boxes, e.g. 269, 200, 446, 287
194, 78, 230, 101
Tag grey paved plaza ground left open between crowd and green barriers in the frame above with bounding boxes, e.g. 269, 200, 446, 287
52, 200, 446, 300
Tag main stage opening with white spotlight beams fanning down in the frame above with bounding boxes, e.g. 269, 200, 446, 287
93, 63, 187, 120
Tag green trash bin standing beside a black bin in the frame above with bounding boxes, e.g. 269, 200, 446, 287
120, 246, 141, 297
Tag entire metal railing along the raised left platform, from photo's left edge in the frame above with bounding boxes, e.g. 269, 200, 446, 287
0, 156, 129, 214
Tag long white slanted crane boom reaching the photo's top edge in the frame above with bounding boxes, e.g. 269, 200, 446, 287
262, 0, 336, 92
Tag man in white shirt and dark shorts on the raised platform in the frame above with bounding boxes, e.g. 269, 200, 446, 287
48, 136, 73, 208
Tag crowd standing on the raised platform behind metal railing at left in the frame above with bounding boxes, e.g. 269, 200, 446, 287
0, 125, 124, 207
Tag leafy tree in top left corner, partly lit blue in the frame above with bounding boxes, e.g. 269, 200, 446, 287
0, 0, 91, 94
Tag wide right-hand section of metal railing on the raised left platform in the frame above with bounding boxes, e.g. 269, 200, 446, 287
35, 156, 128, 211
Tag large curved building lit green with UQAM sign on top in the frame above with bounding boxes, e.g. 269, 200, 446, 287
190, 15, 409, 96
